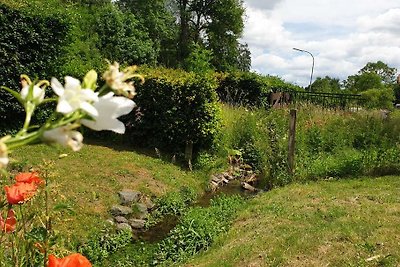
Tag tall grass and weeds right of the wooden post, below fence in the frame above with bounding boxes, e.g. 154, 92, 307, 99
296, 109, 400, 179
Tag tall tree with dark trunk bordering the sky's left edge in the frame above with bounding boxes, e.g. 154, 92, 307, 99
174, 0, 250, 70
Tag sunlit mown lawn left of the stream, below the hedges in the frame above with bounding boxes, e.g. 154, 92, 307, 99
6, 144, 205, 247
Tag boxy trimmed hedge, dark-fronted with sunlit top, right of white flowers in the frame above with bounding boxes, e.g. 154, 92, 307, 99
128, 68, 220, 153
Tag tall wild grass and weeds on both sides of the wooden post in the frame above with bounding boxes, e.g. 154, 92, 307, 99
217, 105, 400, 188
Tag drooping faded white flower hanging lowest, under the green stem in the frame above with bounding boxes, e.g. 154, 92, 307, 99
43, 125, 83, 151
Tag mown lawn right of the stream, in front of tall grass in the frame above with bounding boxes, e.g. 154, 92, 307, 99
188, 176, 400, 266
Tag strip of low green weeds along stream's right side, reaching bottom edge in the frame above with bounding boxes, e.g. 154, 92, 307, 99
105, 196, 244, 266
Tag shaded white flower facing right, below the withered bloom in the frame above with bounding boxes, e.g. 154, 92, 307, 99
81, 92, 136, 134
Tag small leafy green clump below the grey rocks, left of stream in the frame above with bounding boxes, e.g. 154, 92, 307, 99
78, 230, 132, 264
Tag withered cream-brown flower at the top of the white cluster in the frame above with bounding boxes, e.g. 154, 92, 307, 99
103, 62, 144, 98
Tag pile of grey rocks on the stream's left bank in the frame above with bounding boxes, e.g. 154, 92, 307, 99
110, 190, 154, 231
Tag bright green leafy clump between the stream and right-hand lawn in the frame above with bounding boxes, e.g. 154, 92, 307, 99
155, 196, 243, 266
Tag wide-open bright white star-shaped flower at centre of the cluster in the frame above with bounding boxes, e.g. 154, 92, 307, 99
51, 76, 98, 117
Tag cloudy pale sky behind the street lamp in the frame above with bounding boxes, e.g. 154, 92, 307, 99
241, 0, 400, 86
